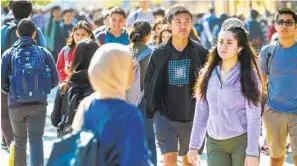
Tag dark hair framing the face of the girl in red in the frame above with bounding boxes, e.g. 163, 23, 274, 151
66, 21, 95, 47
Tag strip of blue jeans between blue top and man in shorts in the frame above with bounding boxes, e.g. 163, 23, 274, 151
138, 99, 157, 166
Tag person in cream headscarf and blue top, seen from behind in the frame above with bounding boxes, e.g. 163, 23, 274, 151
72, 43, 151, 166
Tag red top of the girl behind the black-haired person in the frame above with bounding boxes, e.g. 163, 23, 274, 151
57, 46, 75, 82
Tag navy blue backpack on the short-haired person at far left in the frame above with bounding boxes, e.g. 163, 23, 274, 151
9, 45, 51, 102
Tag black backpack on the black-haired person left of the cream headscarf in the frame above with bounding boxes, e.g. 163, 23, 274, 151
57, 82, 94, 137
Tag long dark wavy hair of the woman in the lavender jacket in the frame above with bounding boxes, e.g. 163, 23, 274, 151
195, 27, 261, 105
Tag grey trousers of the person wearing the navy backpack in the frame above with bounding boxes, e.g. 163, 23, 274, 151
9, 105, 46, 166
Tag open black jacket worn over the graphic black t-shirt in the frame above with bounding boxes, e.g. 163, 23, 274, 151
144, 39, 208, 119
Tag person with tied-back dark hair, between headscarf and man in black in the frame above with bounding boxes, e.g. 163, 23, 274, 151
128, 21, 157, 165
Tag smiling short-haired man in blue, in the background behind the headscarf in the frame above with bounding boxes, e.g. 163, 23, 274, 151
95, 7, 129, 46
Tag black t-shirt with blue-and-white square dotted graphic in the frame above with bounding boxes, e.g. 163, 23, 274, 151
162, 44, 196, 122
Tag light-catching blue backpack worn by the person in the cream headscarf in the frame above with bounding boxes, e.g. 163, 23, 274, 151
46, 96, 118, 166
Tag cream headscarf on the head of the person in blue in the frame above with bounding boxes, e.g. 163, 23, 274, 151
88, 43, 134, 99
